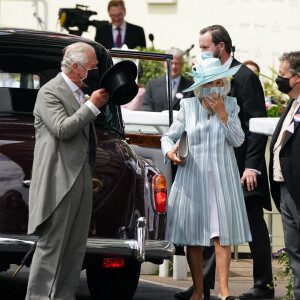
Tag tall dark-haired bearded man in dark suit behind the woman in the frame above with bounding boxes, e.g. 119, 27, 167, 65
175, 25, 274, 299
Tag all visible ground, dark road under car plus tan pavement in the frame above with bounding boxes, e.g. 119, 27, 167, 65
0, 259, 287, 300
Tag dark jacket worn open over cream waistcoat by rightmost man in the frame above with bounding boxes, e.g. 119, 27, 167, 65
269, 100, 300, 215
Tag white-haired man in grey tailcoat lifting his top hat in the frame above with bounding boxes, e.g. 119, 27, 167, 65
26, 42, 109, 300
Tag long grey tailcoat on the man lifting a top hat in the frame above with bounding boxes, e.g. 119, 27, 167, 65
28, 74, 97, 234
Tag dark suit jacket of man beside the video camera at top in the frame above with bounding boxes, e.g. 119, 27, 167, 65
95, 22, 146, 49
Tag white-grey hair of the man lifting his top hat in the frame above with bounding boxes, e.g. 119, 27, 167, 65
61, 42, 95, 74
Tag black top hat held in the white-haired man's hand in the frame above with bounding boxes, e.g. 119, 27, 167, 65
99, 60, 139, 105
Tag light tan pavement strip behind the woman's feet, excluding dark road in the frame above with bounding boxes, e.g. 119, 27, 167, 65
140, 259, 287, 300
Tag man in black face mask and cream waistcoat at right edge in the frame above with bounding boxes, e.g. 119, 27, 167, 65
269, 51, 300, 299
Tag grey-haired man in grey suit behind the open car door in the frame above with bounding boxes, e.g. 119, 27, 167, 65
142, 48, 193, 112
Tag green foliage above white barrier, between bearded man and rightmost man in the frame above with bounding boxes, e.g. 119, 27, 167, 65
258, 67, 290, 117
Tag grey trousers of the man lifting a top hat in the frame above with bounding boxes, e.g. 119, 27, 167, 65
26, 162, 93, 300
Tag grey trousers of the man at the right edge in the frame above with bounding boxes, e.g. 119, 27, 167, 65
280, 183, 300, 299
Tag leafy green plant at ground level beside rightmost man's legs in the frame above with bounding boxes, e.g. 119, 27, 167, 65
268, 248, 294, 300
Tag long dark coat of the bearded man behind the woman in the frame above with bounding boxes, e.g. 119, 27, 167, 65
228, 59, 272, 210
